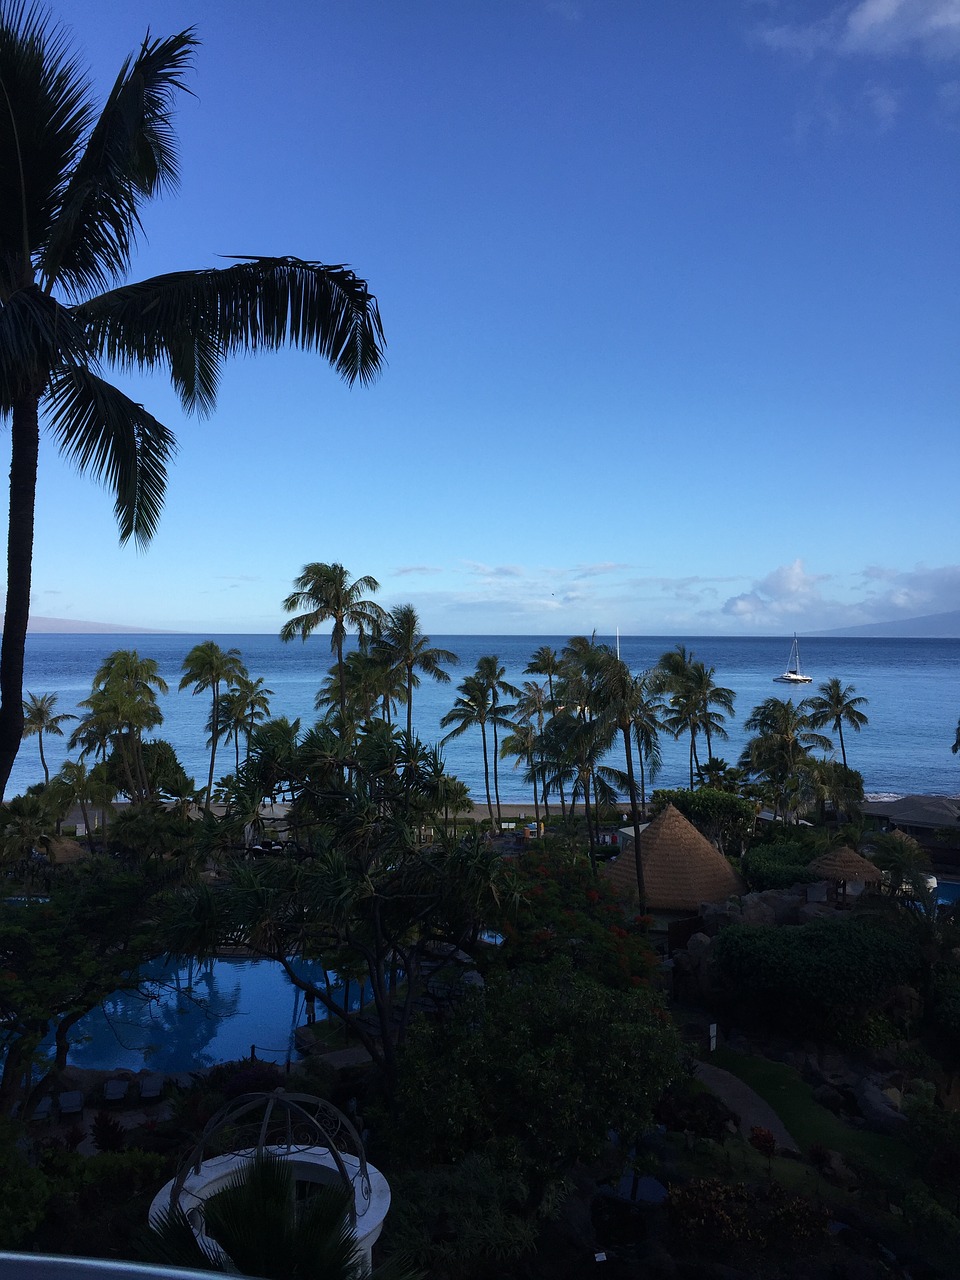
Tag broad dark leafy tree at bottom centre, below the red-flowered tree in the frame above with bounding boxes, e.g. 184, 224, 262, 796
390, 959, 678, 1197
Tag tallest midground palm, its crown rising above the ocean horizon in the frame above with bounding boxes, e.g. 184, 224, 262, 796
280, 561, 387, 719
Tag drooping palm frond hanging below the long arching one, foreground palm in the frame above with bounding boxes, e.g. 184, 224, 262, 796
49, 366, 175, 547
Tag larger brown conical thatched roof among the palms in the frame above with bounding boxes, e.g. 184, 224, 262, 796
602, 804, 745, 911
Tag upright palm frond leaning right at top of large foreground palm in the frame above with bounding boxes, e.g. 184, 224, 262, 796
40, 28, 197, 296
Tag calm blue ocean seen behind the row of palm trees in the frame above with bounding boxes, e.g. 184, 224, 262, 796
6, 635, 960, 809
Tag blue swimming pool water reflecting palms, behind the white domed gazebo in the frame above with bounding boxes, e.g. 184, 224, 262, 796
68, 959, 361, 1074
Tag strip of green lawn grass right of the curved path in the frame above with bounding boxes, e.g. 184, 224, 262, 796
709, 1048, 914, 1184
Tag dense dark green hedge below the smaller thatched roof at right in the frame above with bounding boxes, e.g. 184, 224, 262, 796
713, 915, 920, 1034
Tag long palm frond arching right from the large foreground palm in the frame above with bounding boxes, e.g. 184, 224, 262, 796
78, 257, 384, 412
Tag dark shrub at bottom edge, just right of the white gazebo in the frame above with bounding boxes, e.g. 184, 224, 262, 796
388, 1152, 538, 1280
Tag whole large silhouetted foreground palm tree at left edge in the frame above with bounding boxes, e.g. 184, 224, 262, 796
0, 15, 383, 794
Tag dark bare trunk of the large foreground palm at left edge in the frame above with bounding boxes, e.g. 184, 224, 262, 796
0, 396, 40, 800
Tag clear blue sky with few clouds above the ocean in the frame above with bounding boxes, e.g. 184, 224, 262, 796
20, 0, 960, 635
